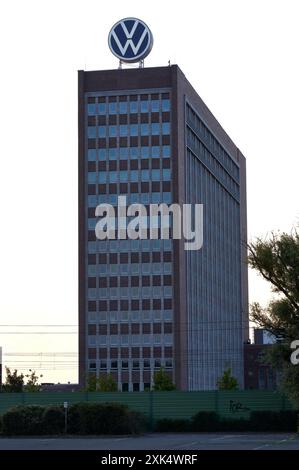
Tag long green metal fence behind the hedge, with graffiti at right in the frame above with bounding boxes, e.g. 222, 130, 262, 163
0, 390, 293, 422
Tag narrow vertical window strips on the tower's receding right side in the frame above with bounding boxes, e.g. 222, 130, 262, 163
185, 105, 243, 390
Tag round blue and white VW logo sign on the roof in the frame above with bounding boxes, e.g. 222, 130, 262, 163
108, 18, 153, 62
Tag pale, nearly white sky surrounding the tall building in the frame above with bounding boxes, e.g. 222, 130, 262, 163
0, 0, 299, 381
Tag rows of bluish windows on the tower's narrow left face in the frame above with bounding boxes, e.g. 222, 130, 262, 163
86, 90, 173, 391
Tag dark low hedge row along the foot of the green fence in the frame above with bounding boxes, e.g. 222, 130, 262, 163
0, 402, 297, 435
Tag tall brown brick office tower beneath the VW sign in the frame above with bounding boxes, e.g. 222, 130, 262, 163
79, 65, 248, 391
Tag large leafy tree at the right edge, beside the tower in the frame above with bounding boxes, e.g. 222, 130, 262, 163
248, 228, 299, 405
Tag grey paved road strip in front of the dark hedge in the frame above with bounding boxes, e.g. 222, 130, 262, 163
0, 433, 299, 450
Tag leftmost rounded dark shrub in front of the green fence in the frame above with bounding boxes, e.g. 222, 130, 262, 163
2, 405, 44, 436
